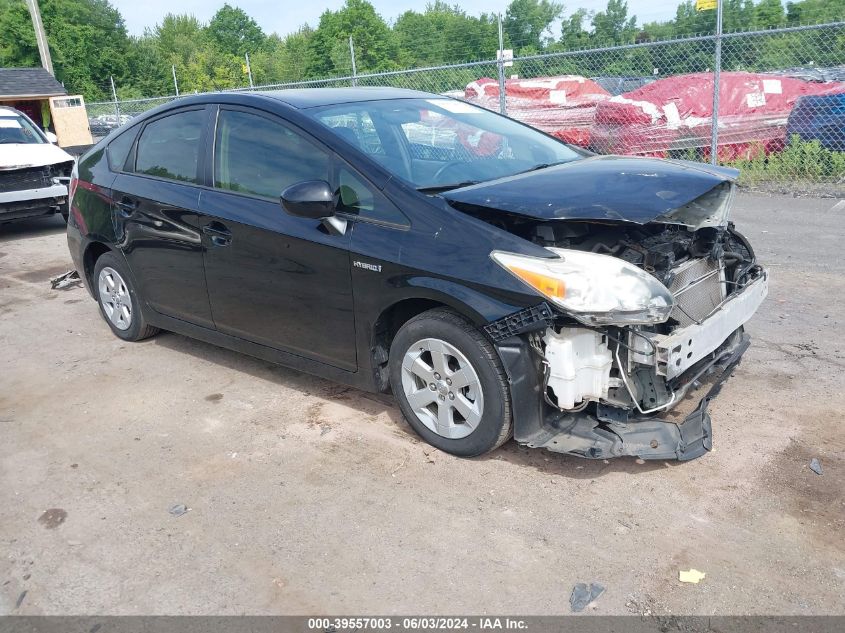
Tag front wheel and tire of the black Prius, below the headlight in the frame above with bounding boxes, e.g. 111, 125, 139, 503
389, 308, 512, 457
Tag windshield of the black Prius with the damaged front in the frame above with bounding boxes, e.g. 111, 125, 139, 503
305, 98, 584, 193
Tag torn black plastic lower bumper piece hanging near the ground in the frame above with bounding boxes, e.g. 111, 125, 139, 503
500, 334, 751, 461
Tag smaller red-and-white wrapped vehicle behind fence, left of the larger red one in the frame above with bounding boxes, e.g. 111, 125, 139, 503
464, 75, 611, 147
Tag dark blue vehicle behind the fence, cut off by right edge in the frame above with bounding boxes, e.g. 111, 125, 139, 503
786, 92, 845, 152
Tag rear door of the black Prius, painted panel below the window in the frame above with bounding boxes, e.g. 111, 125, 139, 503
113, 174, 213, 327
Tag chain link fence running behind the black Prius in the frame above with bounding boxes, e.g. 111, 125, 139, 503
88, 22, 845, 193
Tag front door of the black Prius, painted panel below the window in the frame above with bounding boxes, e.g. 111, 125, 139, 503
200, 190, 357, 370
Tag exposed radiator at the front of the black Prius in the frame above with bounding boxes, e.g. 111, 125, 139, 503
669, 258, 725, 327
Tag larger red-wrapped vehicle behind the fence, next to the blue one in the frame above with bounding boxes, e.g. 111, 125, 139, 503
590, 72, 845, 160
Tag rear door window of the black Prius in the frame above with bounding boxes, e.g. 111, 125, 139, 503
135, 110, 205, 183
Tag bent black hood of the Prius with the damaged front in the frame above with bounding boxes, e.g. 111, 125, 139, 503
441, 156, 739, 224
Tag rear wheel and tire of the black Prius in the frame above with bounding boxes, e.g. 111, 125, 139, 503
93, 253, 158, 341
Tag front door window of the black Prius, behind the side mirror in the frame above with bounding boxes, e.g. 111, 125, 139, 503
214, 110, 330, 198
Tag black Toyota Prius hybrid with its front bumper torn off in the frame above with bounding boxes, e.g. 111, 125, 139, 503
68, 88, 767, 460
